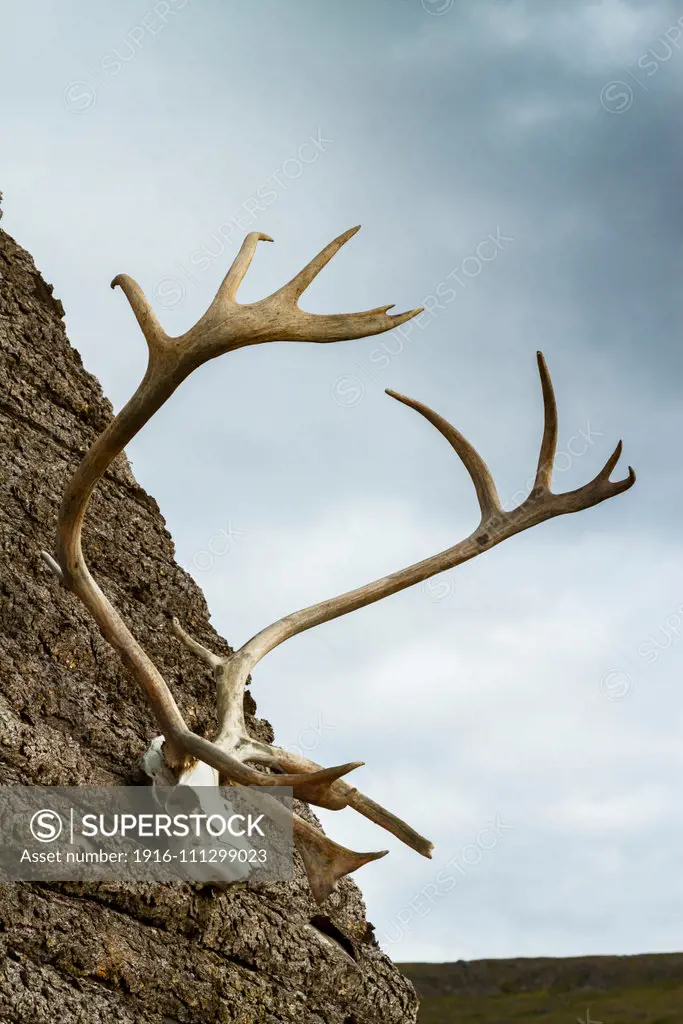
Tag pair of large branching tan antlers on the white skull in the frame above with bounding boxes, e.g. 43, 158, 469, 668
42, 228, 635, 901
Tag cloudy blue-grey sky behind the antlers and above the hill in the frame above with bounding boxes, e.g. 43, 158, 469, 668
0, 0, 683, 961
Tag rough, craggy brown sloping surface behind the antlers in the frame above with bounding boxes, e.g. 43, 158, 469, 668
0, 201, 417, 1024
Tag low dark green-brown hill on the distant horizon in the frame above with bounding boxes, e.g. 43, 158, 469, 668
398, 953, 683, 1024
